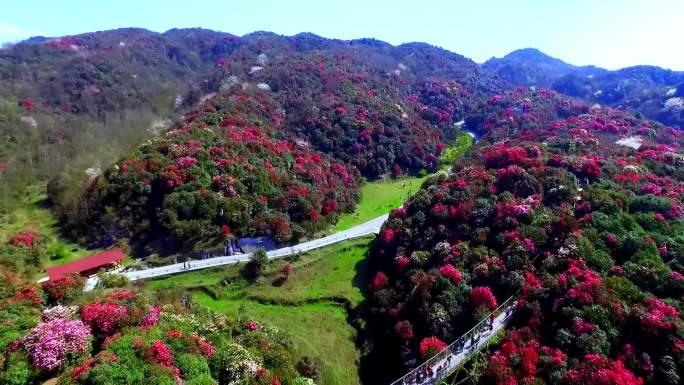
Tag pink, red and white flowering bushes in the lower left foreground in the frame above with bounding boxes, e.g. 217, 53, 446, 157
0, 266, 315, 385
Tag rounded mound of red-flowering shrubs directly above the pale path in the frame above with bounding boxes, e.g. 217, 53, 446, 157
67, 91, 359, 246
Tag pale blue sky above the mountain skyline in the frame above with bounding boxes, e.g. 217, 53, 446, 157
0, 0, 684, 70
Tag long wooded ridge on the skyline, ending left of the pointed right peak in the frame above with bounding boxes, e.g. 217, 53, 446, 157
0, 28, 492, 118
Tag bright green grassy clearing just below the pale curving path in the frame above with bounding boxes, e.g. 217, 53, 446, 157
146, 237, 373, 385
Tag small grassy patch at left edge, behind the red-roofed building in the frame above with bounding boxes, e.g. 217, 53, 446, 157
0, 183, 100, 267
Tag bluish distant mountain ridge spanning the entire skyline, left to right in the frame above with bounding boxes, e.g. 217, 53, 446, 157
0, 28, 684, 128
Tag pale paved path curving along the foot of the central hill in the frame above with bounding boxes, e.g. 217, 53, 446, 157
84, 214, 389, 291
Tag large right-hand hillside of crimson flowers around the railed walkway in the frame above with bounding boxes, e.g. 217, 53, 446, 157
369, 88, 684, 385
